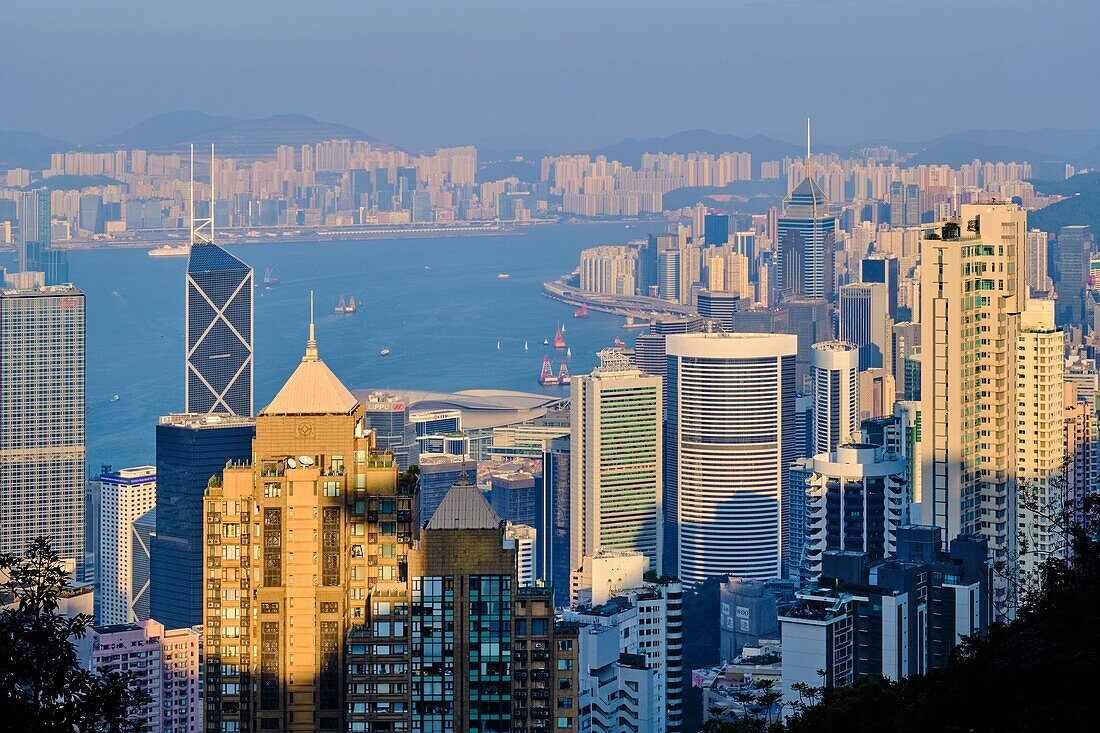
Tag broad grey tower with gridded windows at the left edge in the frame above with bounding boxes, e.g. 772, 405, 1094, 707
0, 285, 85, 565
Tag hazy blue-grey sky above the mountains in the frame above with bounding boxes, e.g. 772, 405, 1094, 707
0, 0, 1100, 150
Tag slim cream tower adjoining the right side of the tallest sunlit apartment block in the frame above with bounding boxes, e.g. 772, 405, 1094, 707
1015, 299, 1068, 573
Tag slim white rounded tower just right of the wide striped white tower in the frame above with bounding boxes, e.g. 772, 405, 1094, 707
812, 341, 859, 456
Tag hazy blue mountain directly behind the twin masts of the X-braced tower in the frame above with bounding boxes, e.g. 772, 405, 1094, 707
94, 111, 388, 157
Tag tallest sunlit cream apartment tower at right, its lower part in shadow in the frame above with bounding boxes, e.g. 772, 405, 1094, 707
920, 204, 1027, 608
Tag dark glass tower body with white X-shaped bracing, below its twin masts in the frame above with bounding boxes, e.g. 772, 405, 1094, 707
184, 242, 254, 417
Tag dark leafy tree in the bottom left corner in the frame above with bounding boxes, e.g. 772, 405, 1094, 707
0, 538, 150, 733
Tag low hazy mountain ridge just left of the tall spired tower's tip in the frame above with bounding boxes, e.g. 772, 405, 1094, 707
590, 130, 840, 168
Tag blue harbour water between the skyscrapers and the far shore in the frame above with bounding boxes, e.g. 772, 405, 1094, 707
4, 225, 647, 470
